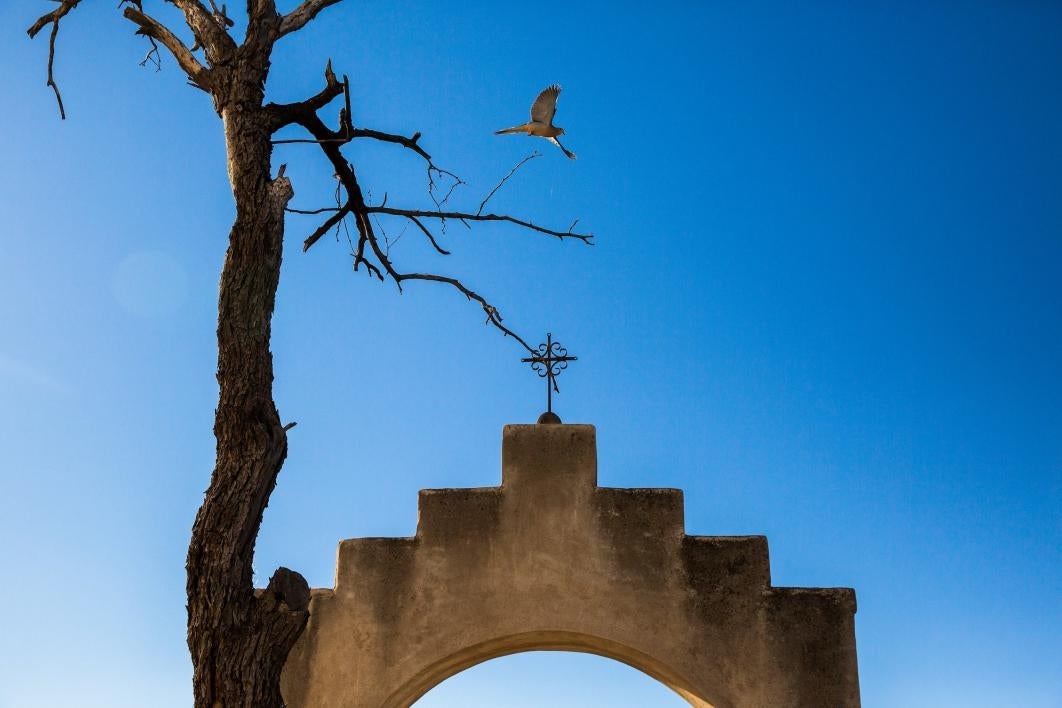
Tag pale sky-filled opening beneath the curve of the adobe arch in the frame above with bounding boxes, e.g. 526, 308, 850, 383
413, 651, 689, 708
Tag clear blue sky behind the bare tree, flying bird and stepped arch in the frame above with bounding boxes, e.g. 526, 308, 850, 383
0, 1, 1062, 708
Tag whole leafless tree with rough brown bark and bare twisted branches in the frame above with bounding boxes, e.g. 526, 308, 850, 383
29, 0, 592, 708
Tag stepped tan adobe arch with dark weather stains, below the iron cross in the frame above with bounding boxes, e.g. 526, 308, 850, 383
281, 425, 859, 708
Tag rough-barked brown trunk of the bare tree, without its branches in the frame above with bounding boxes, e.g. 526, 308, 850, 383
187, 61, 309, 708
